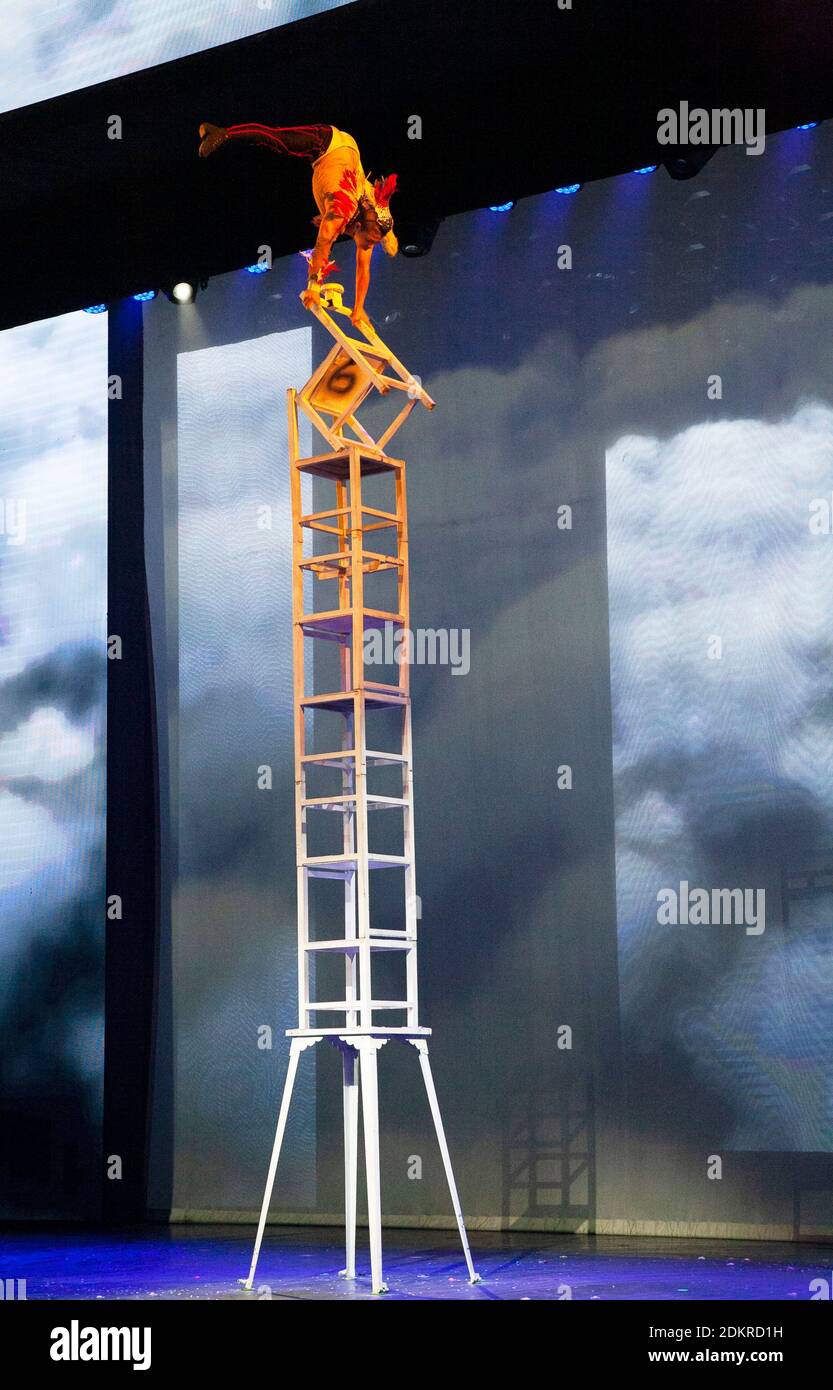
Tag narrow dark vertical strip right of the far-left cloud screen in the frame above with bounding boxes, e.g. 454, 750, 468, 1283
103, 299, 159, 1223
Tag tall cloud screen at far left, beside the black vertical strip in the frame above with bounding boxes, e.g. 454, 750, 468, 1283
0, 313, 107, 1215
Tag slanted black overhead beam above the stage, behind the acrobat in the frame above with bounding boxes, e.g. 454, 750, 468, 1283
0, 0, 833, 328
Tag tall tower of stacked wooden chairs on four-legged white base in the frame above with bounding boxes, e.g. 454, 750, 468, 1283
245, 284, 478, 1294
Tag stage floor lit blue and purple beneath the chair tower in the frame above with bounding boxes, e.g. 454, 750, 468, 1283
0, 1226, 833, 1302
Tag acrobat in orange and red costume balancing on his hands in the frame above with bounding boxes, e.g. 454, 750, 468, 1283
199, 121, 399, 331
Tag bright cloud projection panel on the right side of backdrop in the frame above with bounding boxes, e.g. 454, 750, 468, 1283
608, 378, 833, 1150
